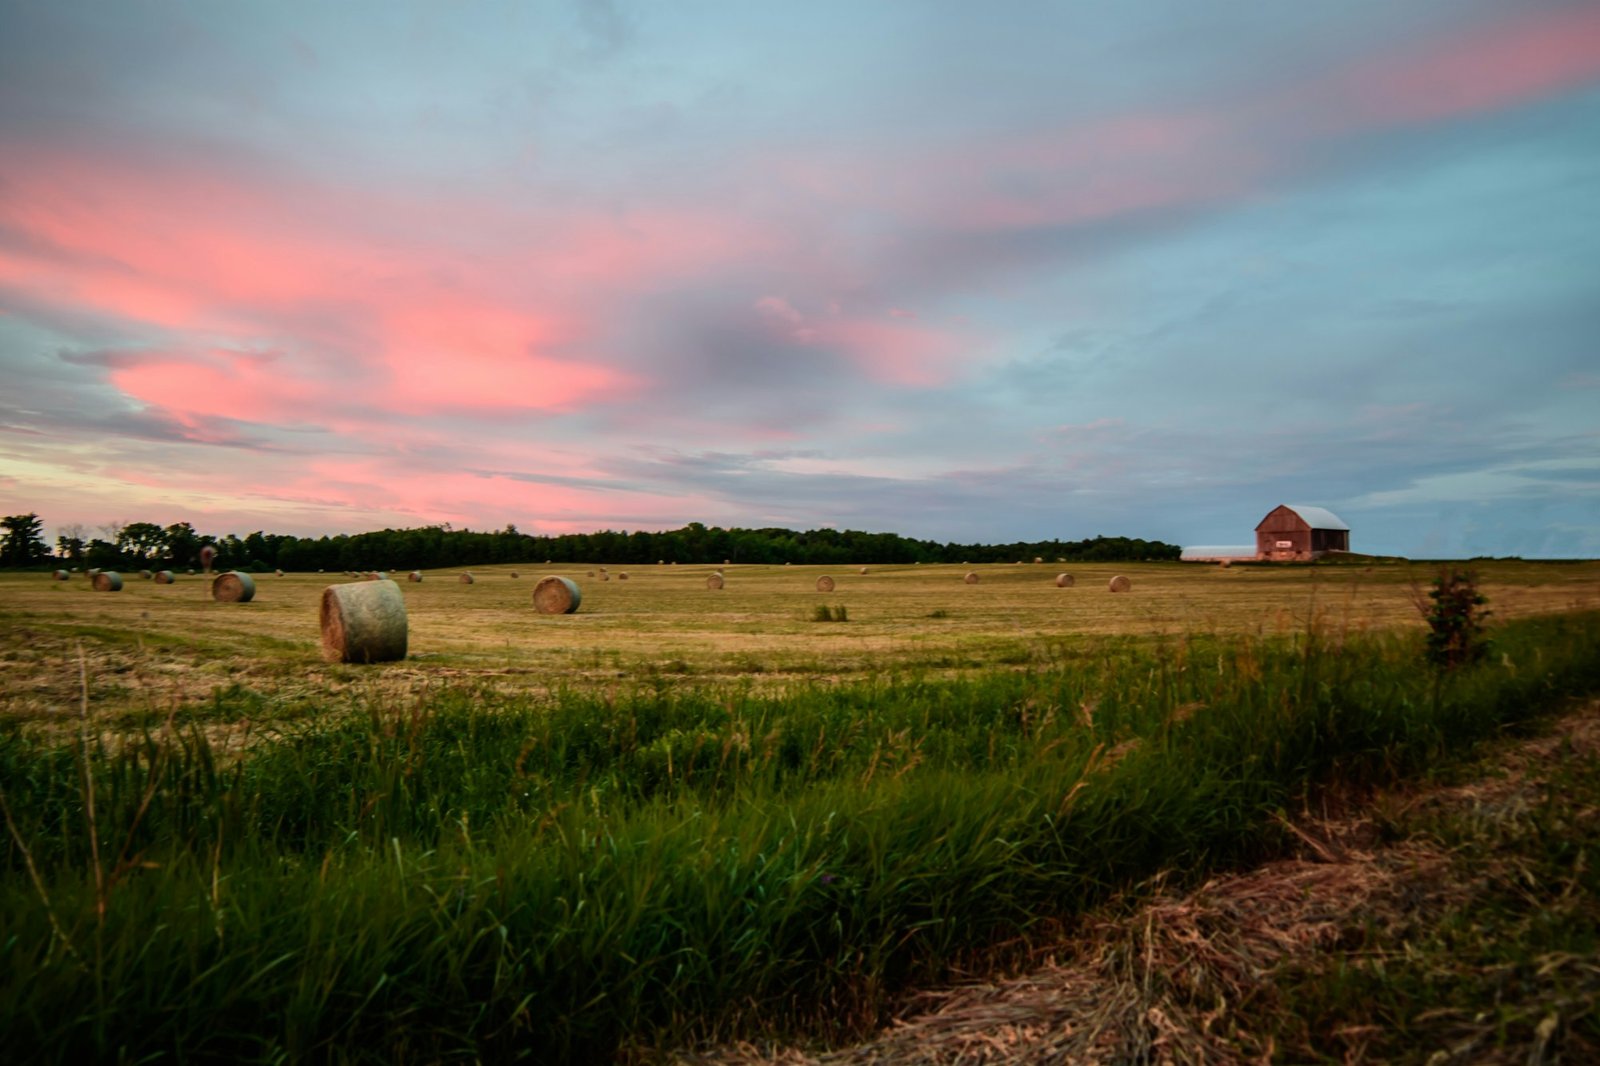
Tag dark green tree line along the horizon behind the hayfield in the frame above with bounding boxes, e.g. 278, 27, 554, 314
0, 514, 1182, 573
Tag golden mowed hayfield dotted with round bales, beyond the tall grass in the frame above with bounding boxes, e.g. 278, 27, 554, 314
0, 562, 1600, 719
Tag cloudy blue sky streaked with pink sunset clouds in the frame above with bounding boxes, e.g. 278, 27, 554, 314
0, 0, 1600, 557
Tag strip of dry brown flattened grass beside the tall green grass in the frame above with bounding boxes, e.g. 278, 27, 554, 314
680, 703, 1600, 1066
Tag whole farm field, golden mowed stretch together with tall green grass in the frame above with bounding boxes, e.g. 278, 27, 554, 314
0, 550, 1600, 1063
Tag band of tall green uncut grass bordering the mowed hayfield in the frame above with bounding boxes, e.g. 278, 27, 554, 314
0, 615, 1600, 1061
